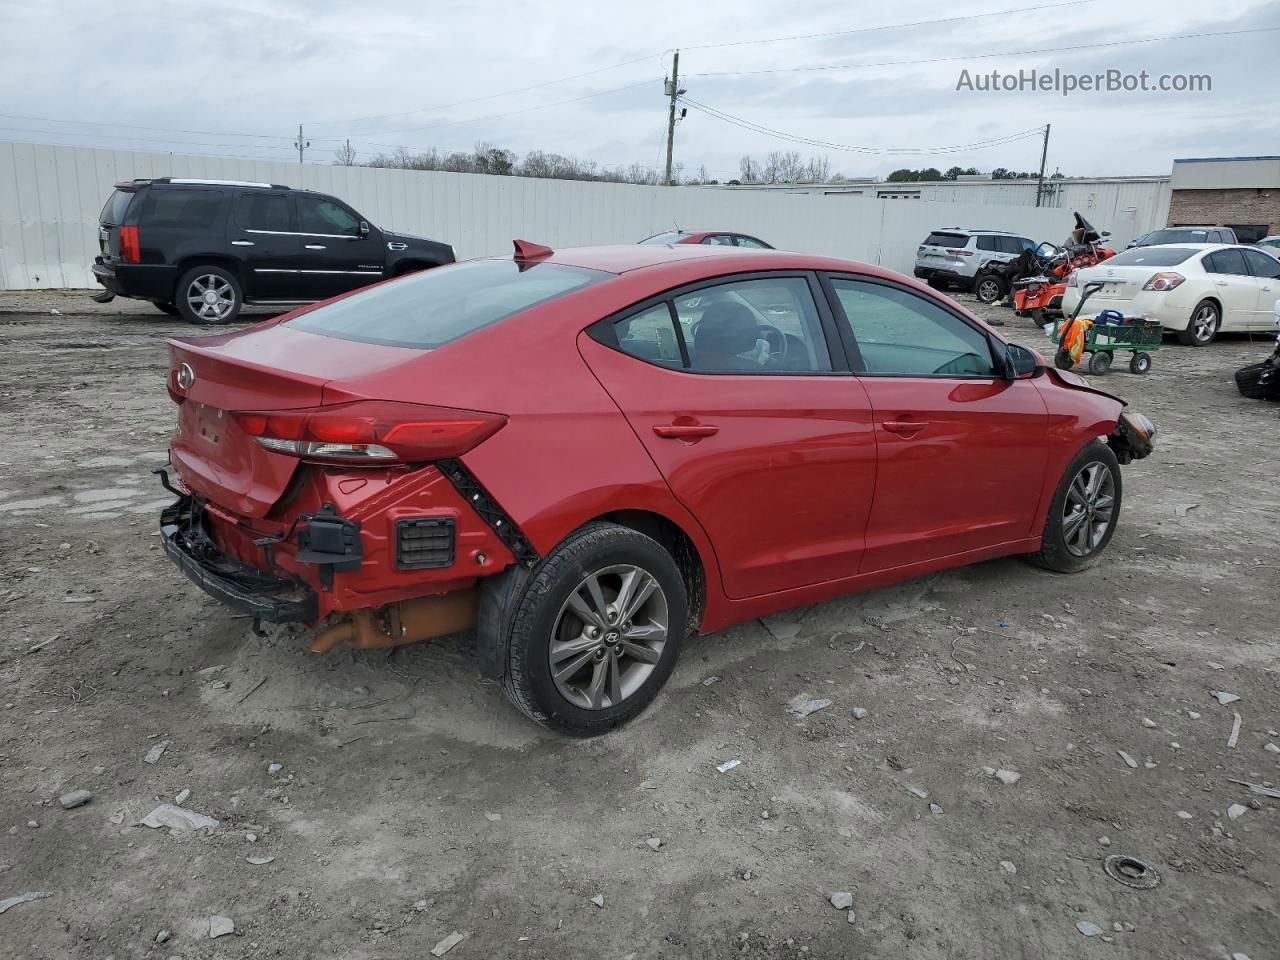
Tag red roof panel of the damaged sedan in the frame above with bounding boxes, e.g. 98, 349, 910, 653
489, 243, 896, 278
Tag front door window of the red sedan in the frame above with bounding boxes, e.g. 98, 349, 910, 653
832, 279, 996, 376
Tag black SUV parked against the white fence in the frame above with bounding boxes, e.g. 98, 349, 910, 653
93, 177, 453, 324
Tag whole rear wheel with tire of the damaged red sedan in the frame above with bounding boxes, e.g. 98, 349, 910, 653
506, 522, 689, 737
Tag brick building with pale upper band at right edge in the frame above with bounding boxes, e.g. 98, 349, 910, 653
1169, 156, 1280, 243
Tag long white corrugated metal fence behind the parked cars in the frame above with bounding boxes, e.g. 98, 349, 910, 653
0, 143, 1080, 289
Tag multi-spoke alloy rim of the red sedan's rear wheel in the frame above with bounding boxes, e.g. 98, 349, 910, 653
548, 563, 668, 710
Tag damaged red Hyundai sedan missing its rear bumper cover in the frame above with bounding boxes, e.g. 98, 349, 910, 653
154, 242, 1155, 735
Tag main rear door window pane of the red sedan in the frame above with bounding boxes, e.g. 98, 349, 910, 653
675, 276, 831, 374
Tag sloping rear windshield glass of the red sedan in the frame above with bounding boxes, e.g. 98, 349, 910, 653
287, 260, 612, 349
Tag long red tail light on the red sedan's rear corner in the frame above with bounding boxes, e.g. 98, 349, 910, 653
233, 401, 507, 463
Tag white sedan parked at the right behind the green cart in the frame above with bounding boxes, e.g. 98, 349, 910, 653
1062, 243, 1280, 347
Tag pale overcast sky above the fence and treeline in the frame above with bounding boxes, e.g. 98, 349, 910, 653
0, 0, 1280, 179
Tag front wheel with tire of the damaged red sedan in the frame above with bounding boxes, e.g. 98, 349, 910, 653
1032, 440, 1121, 573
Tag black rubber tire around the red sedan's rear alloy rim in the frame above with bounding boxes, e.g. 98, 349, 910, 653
504, 522, 689, 737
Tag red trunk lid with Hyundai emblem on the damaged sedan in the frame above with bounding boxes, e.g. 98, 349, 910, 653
169, 324, 424, 518
